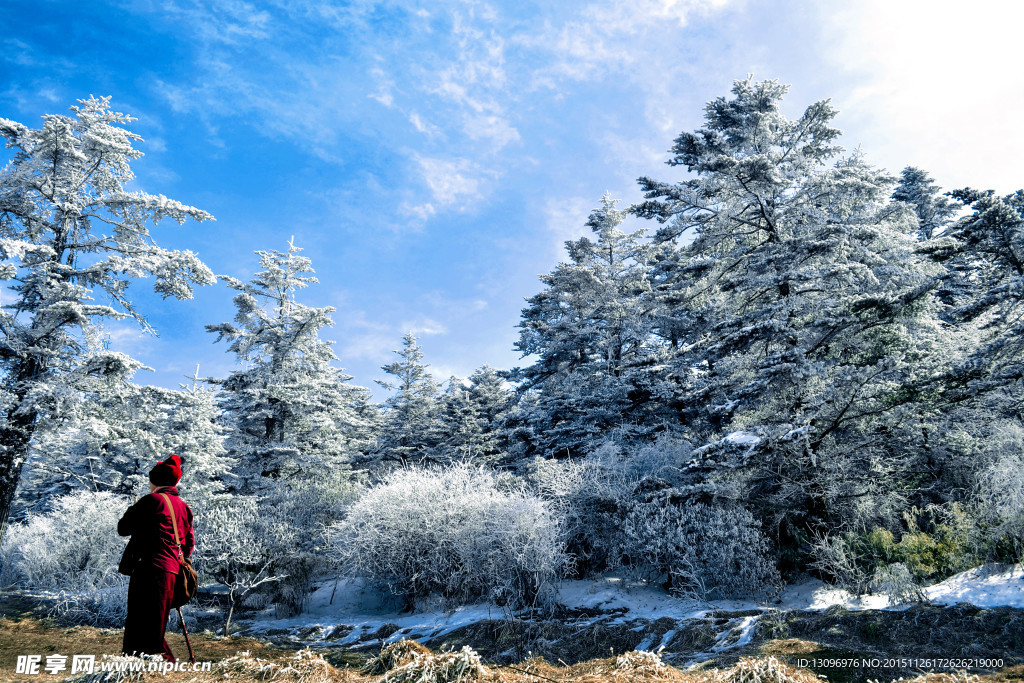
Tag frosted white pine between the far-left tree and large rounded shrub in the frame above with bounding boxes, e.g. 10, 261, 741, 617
207, 243, 370, 493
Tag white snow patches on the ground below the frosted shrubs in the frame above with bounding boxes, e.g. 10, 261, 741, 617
234, 564, 1024, 649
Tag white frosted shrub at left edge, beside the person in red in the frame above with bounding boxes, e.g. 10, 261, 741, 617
0, 492, 130, 591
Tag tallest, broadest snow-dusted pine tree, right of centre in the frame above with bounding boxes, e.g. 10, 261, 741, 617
635, 79, 939, 545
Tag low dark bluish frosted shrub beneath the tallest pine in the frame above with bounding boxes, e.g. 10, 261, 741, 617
623, 490, 781, 600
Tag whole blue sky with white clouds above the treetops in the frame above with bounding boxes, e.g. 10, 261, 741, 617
0, 0, 1024, 397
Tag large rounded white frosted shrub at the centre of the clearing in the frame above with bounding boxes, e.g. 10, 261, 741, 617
330, 464, 566, 607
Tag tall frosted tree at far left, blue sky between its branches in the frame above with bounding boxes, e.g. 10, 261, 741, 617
0, 97, 214, 533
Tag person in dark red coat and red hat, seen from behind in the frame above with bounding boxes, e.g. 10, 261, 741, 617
118, 455, 196, 661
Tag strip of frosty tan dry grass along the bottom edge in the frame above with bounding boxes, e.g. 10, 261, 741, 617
0, 618, 1024, 683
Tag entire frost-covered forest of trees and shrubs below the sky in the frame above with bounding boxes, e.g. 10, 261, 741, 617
0, 79, 1024, 632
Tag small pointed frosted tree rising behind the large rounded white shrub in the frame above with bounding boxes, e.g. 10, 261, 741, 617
376, 332, 446, 465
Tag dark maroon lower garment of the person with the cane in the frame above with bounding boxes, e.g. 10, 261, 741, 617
121, 567, 176, 661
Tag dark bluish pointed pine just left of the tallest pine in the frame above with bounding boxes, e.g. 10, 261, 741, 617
512, 194, 652, 456
